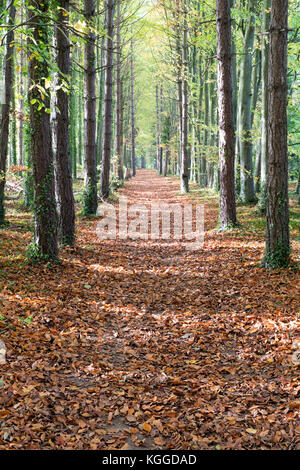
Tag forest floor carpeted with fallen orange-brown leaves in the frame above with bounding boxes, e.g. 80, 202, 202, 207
0, 170, 300, 450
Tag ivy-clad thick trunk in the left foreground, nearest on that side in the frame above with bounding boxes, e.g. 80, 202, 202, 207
28, 0, 58, 260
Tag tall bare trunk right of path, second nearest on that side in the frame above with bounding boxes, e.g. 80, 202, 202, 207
216, 0, 236, 230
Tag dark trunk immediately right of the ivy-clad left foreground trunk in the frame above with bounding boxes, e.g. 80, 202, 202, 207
54, 0, 75, 246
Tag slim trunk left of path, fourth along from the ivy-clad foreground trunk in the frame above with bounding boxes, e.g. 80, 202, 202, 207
101, 0, 115, 199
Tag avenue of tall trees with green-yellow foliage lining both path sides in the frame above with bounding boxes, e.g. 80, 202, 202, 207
0, 0, 300, 268
